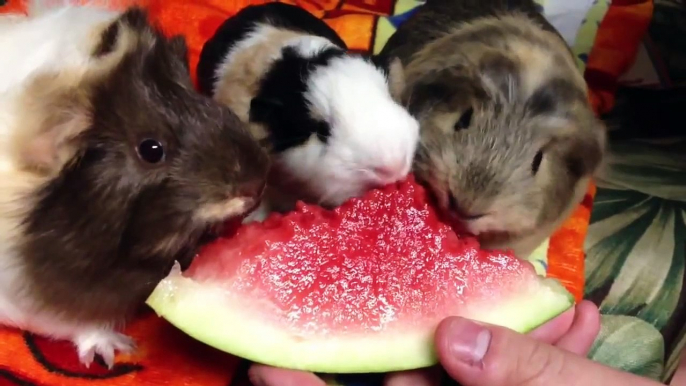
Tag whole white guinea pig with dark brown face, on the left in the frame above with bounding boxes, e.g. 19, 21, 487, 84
0, 1, 269, 366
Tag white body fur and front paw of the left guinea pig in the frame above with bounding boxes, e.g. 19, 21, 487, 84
0, 1, 132, 365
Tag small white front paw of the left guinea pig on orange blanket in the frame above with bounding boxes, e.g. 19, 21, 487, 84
74, 329, 136, 369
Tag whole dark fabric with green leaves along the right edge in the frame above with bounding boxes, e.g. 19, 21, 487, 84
585, 0, 686, 382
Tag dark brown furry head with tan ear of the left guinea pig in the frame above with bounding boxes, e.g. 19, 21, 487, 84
12, 8, 268, 323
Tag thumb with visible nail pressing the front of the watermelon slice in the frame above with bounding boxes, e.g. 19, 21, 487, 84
436, 317, 660, 386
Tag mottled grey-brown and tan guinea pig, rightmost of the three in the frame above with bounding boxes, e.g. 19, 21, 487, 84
380, 0, 606, 257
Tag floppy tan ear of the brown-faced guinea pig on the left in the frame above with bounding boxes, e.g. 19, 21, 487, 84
13, 74, 92, 175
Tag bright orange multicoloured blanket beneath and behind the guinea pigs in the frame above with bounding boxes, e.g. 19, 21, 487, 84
0, 0, 652, 386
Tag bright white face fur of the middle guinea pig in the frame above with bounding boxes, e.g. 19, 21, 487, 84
280, 54, 419, 205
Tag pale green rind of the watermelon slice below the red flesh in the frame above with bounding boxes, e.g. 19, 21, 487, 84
147, 262, 574, 374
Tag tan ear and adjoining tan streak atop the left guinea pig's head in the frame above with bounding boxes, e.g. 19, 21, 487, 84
12, 15, 143, 177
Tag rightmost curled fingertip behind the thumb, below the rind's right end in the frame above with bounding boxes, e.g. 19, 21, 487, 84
555, 300, 600, 356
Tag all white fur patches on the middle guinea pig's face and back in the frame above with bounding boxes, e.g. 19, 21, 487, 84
220, 23, 419, 211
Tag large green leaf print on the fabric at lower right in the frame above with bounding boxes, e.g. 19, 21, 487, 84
585, 140, 686, 380
